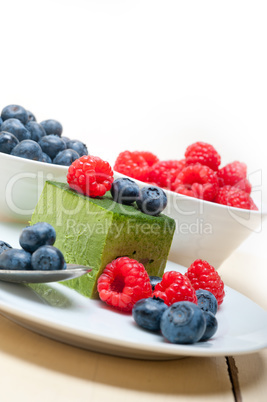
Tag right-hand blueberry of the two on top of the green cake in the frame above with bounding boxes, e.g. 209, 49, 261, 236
136, 186, 167, 215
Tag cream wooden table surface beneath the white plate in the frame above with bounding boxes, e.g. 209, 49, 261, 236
0, 220, 267, 402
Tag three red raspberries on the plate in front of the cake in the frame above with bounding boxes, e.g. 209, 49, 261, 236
97, 257, 225, 312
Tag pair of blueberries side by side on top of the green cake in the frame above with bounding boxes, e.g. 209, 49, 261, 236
110, 177, 167, 216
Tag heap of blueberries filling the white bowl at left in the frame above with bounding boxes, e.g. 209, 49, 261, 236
0, 105, 88, 166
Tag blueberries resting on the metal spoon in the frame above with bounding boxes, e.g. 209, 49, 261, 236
0, 222, 66, 271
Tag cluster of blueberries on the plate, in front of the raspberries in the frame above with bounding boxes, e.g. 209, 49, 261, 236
132, 286, 218, 344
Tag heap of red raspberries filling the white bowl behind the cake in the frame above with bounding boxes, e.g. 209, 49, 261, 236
114, 141, 258, 210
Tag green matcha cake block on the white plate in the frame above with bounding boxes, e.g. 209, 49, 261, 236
31, 181, 175, 298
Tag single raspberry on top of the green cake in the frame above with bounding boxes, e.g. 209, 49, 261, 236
67, 155, 114, 197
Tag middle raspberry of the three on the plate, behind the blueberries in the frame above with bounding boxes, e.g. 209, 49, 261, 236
153, 271, 197, 306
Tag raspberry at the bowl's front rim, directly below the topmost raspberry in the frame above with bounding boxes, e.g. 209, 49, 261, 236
172, 163, 219, 201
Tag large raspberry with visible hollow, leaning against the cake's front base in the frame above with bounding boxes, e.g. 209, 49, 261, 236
97, 257, 152, 312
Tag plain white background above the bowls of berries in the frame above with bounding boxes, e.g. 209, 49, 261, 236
0, 0, 267, 201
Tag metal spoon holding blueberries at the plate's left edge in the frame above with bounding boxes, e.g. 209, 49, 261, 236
0, 264, 92, 283
